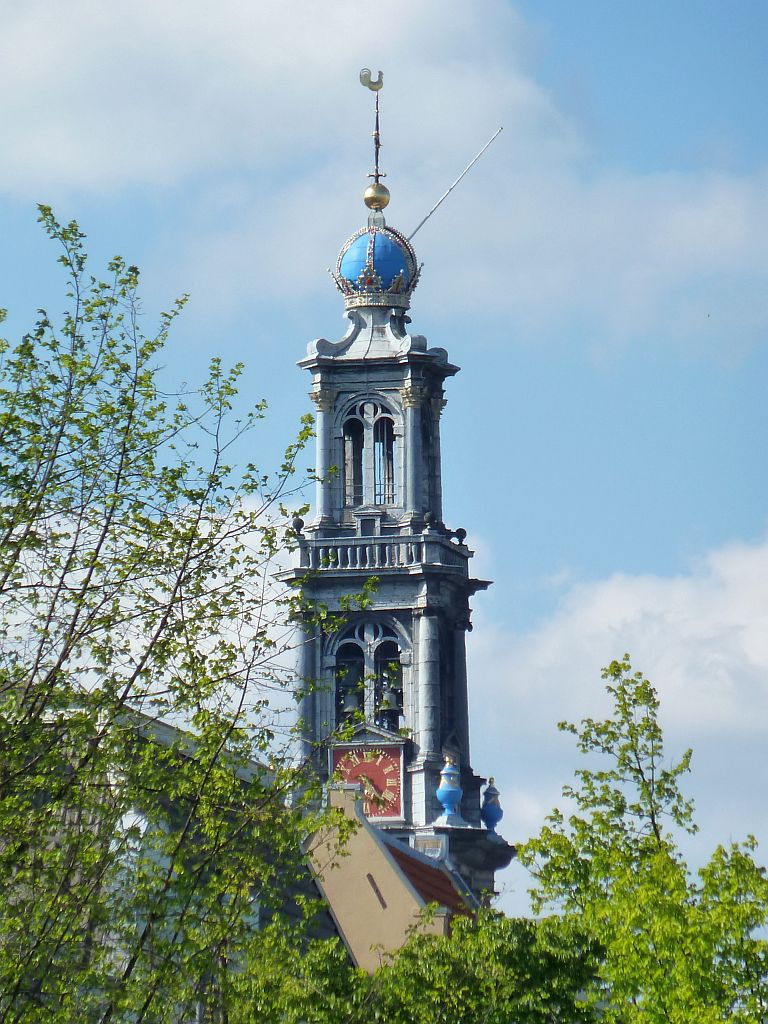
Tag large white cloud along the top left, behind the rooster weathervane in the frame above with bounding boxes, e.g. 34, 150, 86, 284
0, 0, 544, 194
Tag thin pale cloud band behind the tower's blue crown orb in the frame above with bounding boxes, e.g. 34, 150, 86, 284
160, 136, 768, 358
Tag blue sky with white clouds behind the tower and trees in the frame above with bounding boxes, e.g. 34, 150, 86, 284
0, 0, 768, 911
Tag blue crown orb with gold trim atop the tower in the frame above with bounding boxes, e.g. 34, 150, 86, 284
334, 224, 420, 309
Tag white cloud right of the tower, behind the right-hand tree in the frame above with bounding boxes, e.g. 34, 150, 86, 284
469, 540, 768, 909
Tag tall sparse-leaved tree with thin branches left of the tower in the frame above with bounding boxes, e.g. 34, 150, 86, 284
0, 207, 333, 1024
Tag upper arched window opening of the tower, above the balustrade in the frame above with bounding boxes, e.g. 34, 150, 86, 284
342, 401, 398, 508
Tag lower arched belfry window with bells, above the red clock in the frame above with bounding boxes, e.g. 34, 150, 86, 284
336, 623, 402, 732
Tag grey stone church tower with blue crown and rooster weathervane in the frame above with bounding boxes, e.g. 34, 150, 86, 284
285, 72, 514, 894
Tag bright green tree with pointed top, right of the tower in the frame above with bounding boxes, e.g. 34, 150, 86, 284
519, 655, 768, 1024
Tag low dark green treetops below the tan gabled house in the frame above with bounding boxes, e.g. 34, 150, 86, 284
227, 910, 593, 1024
